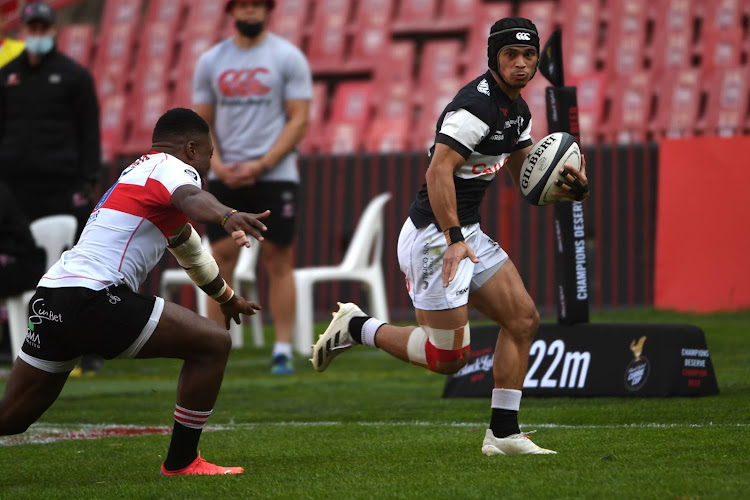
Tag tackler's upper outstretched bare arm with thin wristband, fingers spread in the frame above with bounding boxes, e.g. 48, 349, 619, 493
172, 185, 271, 247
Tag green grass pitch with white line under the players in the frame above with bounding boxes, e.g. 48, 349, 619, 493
0, 311, 750, 499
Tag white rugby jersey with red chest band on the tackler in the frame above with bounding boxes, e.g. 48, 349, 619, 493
38, 152, 201, 291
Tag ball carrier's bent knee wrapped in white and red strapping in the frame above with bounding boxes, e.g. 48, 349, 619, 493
407, 323, 471, 374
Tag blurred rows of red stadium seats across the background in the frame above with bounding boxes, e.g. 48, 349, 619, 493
3, 0, 750, 161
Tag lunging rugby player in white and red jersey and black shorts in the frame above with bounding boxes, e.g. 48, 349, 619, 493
0, 108, 269, 476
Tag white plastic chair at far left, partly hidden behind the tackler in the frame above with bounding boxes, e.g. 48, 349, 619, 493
5, 214, 78, 359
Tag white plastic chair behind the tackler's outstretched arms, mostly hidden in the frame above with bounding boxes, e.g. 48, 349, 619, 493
159, 235, 263, 349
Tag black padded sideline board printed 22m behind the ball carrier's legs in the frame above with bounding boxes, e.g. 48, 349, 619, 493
443, 323, 719, 398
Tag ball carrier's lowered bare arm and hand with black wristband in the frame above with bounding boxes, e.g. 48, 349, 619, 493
426, 143, 479, 287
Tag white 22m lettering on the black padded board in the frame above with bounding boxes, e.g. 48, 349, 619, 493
523, 339, 591, 389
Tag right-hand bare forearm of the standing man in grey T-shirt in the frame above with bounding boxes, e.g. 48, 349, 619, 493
229, 99, 310, 188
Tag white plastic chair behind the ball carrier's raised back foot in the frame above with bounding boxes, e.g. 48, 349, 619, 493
294, 193, 391, 355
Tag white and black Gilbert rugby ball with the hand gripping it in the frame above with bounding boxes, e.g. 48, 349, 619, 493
520, 132, 589, 206
